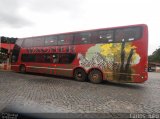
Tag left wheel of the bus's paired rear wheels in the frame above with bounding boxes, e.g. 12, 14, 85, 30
74, 68, 87, 81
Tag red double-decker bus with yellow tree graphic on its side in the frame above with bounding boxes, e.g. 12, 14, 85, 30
11, 24, 148, 83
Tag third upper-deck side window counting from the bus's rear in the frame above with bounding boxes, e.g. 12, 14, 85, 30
74, 32, 91, 44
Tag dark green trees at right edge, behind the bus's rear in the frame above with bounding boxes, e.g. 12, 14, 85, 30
148, 48, 160, 63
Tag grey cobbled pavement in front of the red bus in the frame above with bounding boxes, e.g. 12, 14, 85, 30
0, 71, 160, 117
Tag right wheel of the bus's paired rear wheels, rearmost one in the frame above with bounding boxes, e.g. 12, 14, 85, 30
88, 69, 102, 84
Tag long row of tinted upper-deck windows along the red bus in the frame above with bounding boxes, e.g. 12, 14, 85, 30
19, 26, 143, 47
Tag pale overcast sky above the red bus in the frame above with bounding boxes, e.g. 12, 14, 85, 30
0, 0, 160, 54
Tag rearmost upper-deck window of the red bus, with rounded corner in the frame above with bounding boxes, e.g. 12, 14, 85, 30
115, 27, 142, 42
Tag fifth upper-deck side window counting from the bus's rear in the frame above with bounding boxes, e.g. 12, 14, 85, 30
45, 36, 57, 46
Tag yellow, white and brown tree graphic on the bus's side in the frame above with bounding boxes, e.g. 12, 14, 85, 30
78, 42, 140, 80
